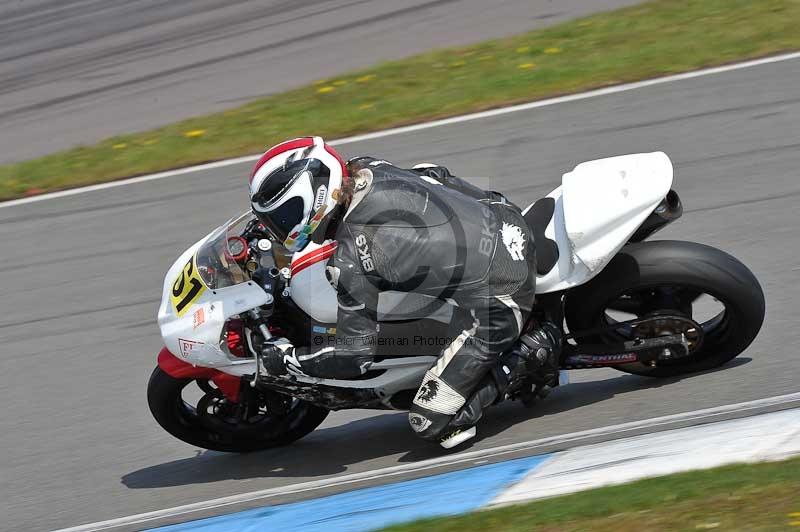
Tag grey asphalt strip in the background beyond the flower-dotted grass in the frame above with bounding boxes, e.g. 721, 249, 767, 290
0, 0, 637, 163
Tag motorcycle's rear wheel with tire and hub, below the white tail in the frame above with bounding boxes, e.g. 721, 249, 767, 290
564, 240, 765, 377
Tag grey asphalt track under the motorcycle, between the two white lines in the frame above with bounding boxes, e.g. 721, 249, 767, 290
0, 56, 800, 530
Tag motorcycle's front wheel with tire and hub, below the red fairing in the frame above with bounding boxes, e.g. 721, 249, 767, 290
147, 367, 329, 453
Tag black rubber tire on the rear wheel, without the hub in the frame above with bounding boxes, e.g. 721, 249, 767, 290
565, 240, 765, 377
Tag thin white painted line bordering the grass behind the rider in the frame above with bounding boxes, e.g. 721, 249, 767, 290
0, 48, 800, 208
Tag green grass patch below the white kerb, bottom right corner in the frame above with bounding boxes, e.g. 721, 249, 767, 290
386, 458, 800, 532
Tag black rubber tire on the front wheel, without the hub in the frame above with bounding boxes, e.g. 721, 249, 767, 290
147, 367, 329, 453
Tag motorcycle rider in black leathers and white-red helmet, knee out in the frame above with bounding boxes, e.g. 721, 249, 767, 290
250, 137, 560, 448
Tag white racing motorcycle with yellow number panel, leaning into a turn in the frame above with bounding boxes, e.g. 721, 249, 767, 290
147, 152, 765, 452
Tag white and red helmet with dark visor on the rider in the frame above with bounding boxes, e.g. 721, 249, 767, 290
250, 137, 347, 252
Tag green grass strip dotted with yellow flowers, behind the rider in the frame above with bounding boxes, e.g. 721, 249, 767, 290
0, 0, 800, 199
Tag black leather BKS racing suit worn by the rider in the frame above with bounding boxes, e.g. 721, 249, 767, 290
280, 157, 536, 439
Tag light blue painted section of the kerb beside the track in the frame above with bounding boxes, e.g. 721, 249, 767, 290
148, 455, 550, 532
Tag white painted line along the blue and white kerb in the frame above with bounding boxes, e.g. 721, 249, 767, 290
55, 393, 800, 532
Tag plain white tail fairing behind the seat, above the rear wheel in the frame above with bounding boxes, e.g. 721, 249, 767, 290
526, 152, 672, 293
